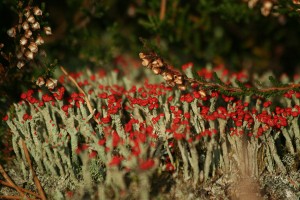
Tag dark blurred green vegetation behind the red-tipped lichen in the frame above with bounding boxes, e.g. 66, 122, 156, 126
0, 0, 300, 162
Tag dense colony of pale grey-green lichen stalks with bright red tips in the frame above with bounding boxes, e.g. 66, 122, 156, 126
4, 59, 300, 199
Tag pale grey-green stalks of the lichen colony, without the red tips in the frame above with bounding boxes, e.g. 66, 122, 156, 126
2, 67, 300, 199
